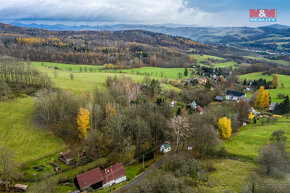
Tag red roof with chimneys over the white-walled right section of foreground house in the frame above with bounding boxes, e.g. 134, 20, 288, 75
101, 163, 126, 184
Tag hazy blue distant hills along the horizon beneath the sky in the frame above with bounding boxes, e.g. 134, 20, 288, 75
7, 23, 290, 53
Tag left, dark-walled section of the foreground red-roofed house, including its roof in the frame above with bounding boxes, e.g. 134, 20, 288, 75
74, 168, 104, 191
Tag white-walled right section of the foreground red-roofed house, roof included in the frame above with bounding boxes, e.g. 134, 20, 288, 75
101, 163, 126, 187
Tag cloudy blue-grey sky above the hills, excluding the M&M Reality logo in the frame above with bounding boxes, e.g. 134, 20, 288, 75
0, 0, 290, 26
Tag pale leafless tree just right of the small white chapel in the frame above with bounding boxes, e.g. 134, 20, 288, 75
168, 116, 189, 153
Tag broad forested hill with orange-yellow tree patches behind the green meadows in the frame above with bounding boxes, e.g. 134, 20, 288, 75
0, 24, 209, 68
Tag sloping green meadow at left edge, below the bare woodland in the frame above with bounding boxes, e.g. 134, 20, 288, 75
0, 97, 64, 162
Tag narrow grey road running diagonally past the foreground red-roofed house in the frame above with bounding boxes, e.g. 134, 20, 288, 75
114, 153, 172, 193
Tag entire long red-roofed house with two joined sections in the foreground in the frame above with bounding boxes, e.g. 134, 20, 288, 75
74, 163, 127, 191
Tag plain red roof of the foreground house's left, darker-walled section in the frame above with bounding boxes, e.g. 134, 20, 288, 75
76, 168, 104, 189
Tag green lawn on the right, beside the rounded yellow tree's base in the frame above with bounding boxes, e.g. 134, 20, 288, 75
224, 118, 290, 159
